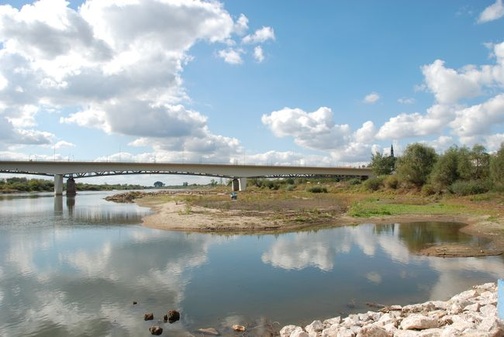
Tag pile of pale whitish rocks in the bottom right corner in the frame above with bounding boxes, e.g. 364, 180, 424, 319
280, 283, 504, 337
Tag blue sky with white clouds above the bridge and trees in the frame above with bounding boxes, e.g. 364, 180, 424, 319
0, 0, 504, 184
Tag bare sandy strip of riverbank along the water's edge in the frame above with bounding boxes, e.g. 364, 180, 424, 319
136, 199, 504, 257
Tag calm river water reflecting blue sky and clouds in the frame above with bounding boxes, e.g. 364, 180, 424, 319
0, 192, 504, 337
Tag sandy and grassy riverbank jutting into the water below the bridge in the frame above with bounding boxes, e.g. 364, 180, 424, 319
107, 189, 504, 257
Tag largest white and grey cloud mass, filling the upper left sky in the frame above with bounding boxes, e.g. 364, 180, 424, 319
0, 0, 274, 160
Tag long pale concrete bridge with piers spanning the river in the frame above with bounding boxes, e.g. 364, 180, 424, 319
0, 161, 373, 195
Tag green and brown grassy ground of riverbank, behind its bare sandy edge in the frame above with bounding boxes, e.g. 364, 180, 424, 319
132, 185, 504, 224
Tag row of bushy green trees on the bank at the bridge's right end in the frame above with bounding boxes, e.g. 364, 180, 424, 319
365, 143, 504, 195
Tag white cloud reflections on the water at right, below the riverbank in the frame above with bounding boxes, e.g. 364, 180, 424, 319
262, 224, 504, 299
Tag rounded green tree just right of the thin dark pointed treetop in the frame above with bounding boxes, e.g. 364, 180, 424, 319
396, 143, 437, 187
